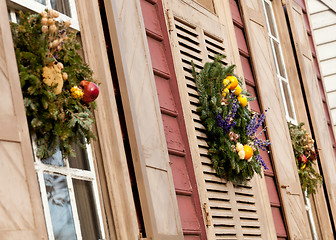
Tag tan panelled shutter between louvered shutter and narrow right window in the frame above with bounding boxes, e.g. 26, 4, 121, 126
240, 0, 311, 239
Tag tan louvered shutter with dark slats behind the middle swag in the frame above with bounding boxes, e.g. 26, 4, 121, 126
167, 0, 270, 239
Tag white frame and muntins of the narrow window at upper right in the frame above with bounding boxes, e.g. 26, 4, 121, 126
261, 0, 298, 125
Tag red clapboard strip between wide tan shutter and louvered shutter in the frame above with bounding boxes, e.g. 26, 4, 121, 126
141, 0, 206, 239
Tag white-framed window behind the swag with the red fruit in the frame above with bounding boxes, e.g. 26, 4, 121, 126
7, 0, 106, 240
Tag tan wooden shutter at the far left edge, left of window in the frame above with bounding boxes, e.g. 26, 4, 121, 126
0, 1, 47, 240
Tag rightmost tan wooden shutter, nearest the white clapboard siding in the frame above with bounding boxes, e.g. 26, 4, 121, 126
286, 0, 336, 227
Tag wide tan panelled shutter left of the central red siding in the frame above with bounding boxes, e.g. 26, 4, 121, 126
104, 0, 183, 240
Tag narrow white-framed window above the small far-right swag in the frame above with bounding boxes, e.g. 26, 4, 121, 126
262, 0, 297, 124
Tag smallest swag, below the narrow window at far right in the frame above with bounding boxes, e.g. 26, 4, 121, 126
288, 122, 323, 196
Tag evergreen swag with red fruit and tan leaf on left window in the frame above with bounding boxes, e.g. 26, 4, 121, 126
11, 10, 99, 159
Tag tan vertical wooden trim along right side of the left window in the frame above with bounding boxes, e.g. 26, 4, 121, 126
76, 1, 139, 239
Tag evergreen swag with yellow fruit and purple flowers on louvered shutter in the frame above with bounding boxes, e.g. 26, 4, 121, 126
192, 56, 271, 184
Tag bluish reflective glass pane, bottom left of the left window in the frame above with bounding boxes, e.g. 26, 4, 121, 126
44, 174, 76, 240
